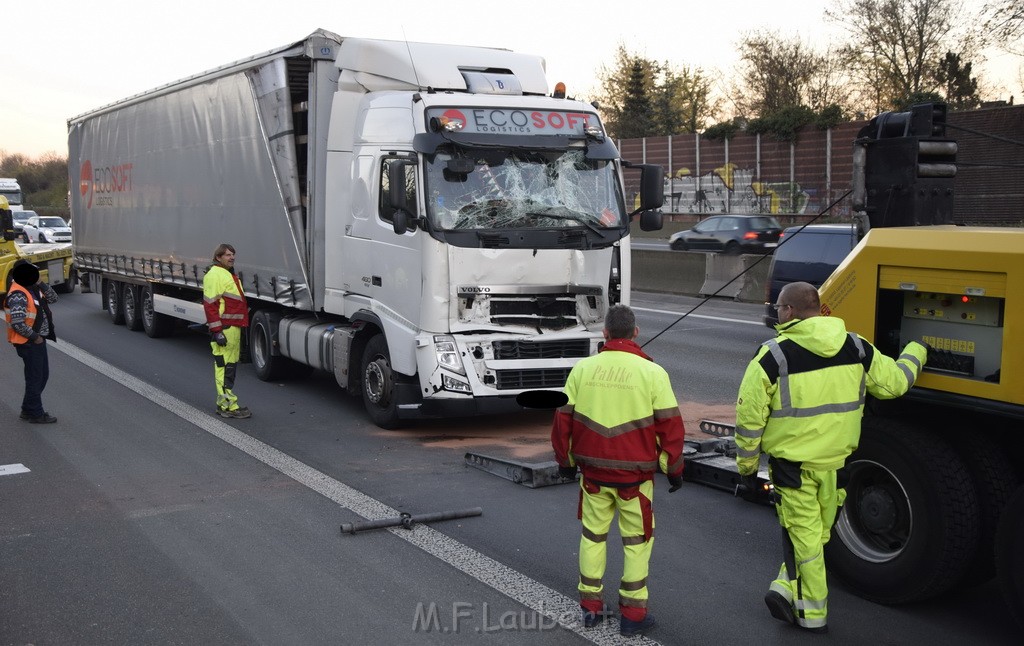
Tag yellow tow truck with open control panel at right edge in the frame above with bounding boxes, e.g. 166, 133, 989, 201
820, 104, 1024, 625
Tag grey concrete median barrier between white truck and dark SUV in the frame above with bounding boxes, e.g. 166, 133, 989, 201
633, 249, 771, 303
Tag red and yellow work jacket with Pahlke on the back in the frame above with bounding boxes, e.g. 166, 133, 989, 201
551, 339, 685, 485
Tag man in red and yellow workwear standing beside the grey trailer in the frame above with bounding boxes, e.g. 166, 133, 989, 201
203, 245, 252, 419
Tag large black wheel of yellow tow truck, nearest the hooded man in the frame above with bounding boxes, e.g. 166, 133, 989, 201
825, 416, 980, 604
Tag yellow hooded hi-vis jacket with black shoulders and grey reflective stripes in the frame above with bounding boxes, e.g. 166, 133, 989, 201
736, 316, 928, 474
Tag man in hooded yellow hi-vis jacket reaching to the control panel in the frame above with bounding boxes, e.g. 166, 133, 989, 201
736, 283, 928, 633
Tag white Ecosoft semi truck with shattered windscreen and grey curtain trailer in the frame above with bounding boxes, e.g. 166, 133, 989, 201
69, 30, 662, 428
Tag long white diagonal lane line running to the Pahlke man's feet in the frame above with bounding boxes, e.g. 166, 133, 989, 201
49, 341, 657, 645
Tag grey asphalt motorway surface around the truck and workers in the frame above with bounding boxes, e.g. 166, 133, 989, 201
0, 293, 1019, 644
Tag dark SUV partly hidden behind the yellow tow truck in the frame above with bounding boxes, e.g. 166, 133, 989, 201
762, 224, 858, 328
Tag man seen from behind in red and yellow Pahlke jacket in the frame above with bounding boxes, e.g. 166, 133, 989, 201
551, 305, 685, 636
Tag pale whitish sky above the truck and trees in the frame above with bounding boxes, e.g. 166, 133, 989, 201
0, 0, 1024, 159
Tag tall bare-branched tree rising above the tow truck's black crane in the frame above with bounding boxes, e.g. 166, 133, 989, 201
825, 0, 980, 112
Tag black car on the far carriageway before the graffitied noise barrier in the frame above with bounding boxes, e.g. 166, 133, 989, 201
669, 215, 782, 254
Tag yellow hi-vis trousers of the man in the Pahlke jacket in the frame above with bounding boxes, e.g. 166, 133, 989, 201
579, 478, 654, 621
